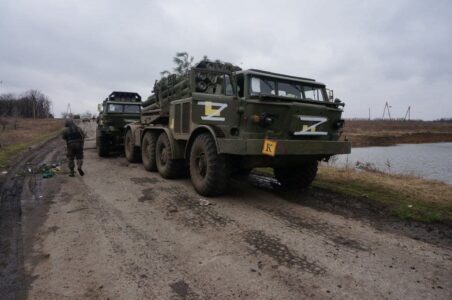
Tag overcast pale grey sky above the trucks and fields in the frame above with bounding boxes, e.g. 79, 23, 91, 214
0, 0, 452, 119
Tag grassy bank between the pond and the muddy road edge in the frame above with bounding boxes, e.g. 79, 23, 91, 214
254, 165, 452, 224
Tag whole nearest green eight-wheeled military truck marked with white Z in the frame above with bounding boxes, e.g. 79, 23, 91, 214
125, 61, 351, 196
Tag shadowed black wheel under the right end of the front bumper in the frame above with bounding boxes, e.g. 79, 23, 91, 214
274, 160, 319, 188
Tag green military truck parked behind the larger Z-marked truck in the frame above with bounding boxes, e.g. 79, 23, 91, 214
96, 91, 141, 157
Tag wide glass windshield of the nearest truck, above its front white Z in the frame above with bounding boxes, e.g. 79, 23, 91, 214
250, 77, 325, 101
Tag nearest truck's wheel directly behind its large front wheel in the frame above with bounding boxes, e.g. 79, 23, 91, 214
155, 132, 183, 179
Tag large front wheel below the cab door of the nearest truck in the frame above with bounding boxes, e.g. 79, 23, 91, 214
189, 133, 231, 196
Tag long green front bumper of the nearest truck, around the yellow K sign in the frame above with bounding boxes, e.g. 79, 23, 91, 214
217, 139, 352, 156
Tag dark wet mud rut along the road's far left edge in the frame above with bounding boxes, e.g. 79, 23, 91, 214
0, 137, 65, 299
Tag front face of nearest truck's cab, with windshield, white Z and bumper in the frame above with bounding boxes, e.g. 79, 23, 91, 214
221, 69, 350, 159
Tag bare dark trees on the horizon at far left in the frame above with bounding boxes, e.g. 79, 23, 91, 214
0, 90, 53, 119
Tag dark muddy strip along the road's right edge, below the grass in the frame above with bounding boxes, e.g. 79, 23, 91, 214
247, 173, 452, 251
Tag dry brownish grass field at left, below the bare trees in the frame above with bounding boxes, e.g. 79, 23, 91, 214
0, 119, 64, 169
